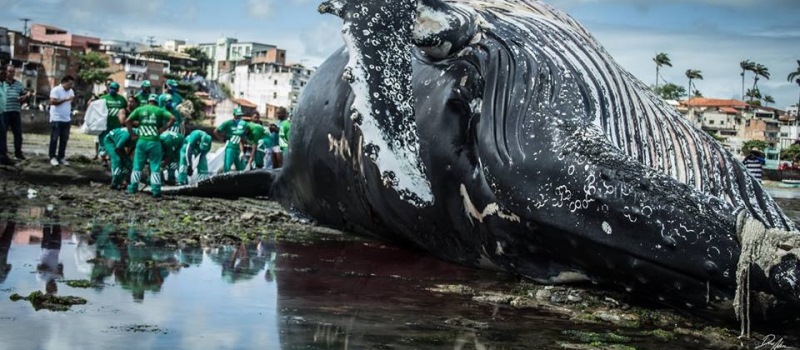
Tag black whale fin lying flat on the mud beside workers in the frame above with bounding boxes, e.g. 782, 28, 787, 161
162, 169, 281, 199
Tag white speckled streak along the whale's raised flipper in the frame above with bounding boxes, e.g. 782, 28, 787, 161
342, 12, 433, 207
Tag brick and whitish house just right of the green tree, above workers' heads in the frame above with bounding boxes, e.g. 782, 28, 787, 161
109, 53, 170, 95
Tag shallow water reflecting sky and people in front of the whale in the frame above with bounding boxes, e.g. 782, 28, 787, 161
0, 215, 736, 349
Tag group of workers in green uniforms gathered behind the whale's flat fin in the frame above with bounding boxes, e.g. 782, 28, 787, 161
91, 80, 291, 197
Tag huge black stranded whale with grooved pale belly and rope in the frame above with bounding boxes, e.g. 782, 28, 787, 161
172, 0, 800, 330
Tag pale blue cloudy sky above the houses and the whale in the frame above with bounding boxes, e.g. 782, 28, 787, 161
0, 0, 800, 108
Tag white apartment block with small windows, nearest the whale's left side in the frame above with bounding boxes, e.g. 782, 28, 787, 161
232, 62, 313, 117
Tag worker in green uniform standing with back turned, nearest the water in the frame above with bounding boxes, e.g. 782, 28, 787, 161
127, 94, 175, 197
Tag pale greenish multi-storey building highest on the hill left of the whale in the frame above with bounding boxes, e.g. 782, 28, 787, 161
197, 38, 278, 80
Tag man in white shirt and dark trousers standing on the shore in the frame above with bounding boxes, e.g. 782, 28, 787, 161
50, 75, 75, 166
